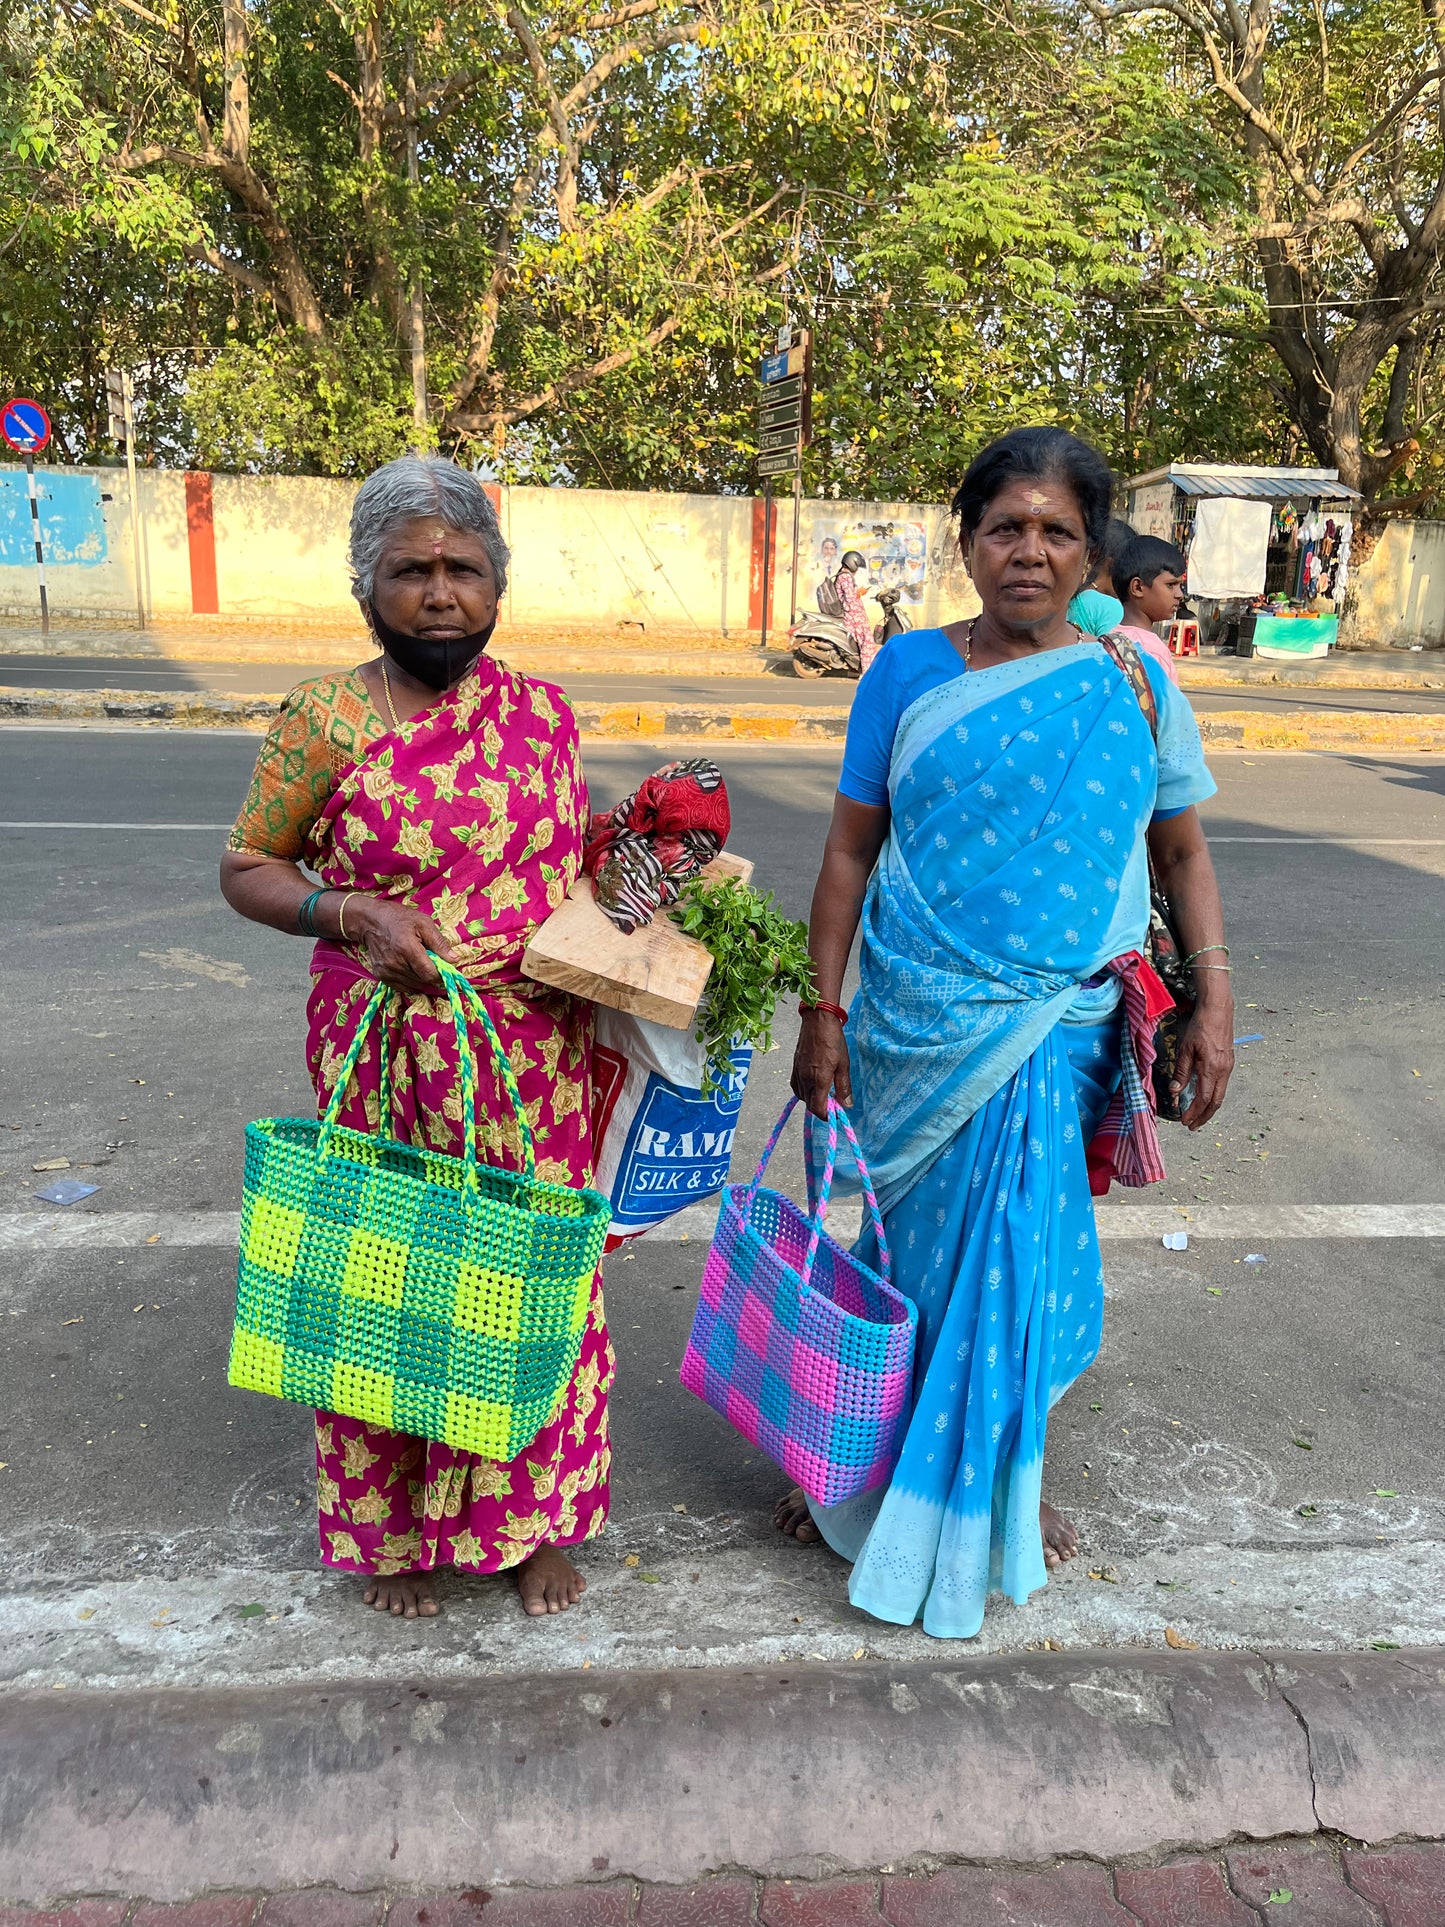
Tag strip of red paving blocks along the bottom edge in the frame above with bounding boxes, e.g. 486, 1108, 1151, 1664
0, 1838, 1445, 1927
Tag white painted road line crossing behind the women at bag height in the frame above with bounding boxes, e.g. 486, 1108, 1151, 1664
0, 1204, 1445, 1251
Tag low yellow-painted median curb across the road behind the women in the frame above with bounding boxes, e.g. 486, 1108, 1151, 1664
0, 690, 1445, 752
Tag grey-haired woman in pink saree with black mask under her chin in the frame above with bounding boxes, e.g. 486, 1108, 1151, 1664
222, 457, 613, 1619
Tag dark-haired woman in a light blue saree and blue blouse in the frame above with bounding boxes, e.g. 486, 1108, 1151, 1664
778, 428, 1233, 1638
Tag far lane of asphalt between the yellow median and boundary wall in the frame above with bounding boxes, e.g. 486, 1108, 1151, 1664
0, 655, 1445, 715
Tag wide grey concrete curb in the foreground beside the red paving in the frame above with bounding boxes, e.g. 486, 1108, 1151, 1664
0, 1646, 1445, 1900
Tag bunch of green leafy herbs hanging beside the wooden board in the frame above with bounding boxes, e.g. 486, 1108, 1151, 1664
672, 877, 815, 1095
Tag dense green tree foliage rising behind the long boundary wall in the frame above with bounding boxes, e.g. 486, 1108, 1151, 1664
0, 0, 1445, 499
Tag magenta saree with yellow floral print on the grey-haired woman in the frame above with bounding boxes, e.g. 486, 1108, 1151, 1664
306, 657, 615, 1574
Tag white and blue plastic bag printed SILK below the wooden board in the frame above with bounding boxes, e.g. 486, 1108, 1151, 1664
591, 1004, 753, 1249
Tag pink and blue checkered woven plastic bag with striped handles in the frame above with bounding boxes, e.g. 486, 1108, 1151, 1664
682, 1098, 917, 1505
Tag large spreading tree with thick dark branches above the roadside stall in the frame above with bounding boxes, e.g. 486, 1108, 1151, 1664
1087, 0, 1445, 499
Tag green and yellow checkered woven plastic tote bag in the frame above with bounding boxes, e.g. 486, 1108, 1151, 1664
229, 958, 611, 1461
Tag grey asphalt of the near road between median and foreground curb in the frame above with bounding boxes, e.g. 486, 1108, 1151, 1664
0, 726, 1445, 1657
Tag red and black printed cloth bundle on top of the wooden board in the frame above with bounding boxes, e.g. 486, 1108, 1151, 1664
582, 755, 732, 935
